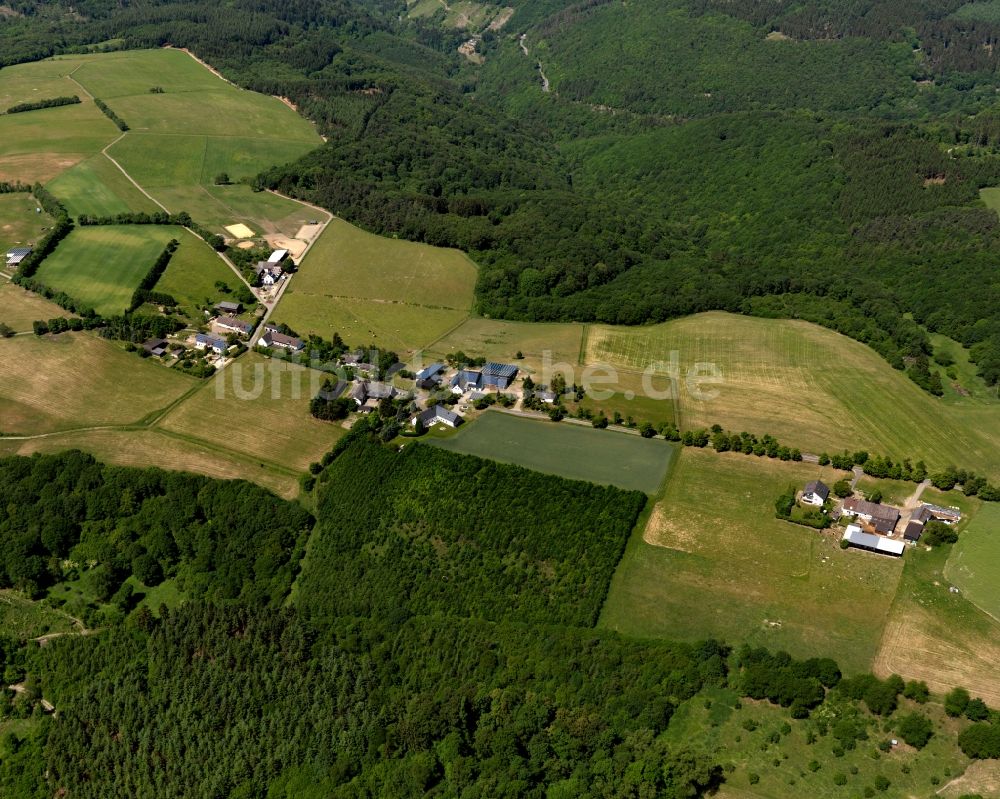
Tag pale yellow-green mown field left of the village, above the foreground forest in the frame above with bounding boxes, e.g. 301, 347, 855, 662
158, 353, 346, 472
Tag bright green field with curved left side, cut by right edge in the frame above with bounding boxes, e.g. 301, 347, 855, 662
945, 502, 1000, 620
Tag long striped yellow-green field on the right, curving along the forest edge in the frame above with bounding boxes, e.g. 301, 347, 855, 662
587, 312, 1000, 479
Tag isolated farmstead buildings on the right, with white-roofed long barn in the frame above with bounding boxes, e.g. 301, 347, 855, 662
800, 480, 962, 557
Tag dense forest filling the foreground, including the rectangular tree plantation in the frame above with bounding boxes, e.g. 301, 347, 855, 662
0, 446, 998, 799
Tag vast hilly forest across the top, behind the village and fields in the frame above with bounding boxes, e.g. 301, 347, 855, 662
0, 0, 1000, 390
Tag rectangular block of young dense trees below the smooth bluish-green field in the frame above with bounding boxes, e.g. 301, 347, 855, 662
299, 442, 646, 626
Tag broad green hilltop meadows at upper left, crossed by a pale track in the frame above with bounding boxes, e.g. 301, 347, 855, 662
0, 49, 322, 236
